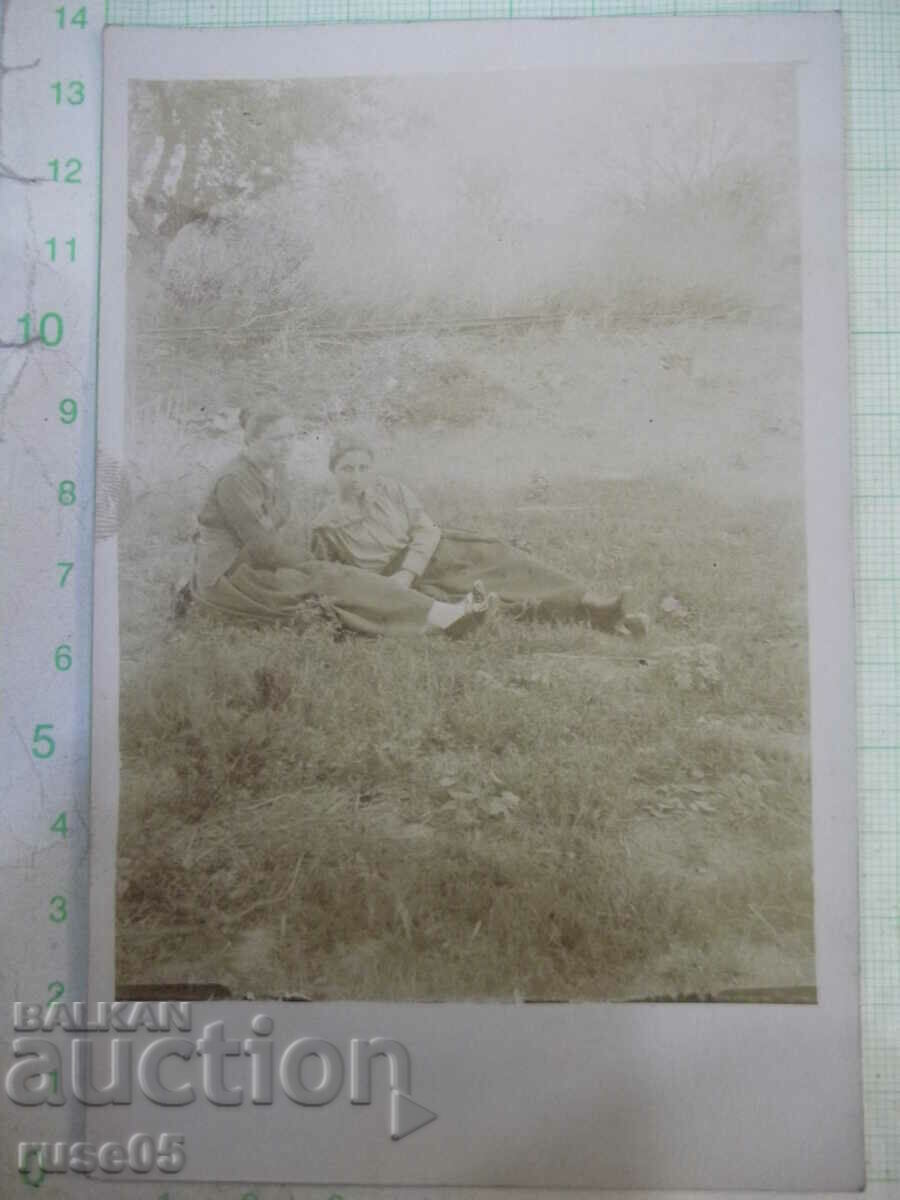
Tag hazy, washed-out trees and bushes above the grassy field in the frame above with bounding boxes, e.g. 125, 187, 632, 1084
131, 67, 797, 336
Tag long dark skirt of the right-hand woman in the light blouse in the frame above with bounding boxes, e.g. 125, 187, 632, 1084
415, 529, 587, 620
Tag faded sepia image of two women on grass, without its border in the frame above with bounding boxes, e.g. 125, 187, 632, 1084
114, 62, 816, 1004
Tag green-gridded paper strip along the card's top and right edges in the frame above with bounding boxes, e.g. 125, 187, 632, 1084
107, 0, 900, 1182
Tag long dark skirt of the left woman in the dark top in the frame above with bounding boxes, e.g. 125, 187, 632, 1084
194, 559, 432, 637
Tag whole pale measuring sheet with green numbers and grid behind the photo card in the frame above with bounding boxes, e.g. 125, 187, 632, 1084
0, 0, 900, 1200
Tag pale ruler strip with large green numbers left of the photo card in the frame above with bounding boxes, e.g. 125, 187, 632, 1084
0, 0, 103, 1180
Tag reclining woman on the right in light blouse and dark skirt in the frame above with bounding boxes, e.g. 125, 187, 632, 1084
312, 436, 647, 636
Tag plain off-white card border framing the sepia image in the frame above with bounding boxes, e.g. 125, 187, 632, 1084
89, 14, 864, 1192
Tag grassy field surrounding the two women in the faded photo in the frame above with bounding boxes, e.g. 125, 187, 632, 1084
118, 310, 815, 1000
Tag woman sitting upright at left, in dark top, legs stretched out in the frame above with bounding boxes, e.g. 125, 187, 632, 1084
191, 408, 490, 636
